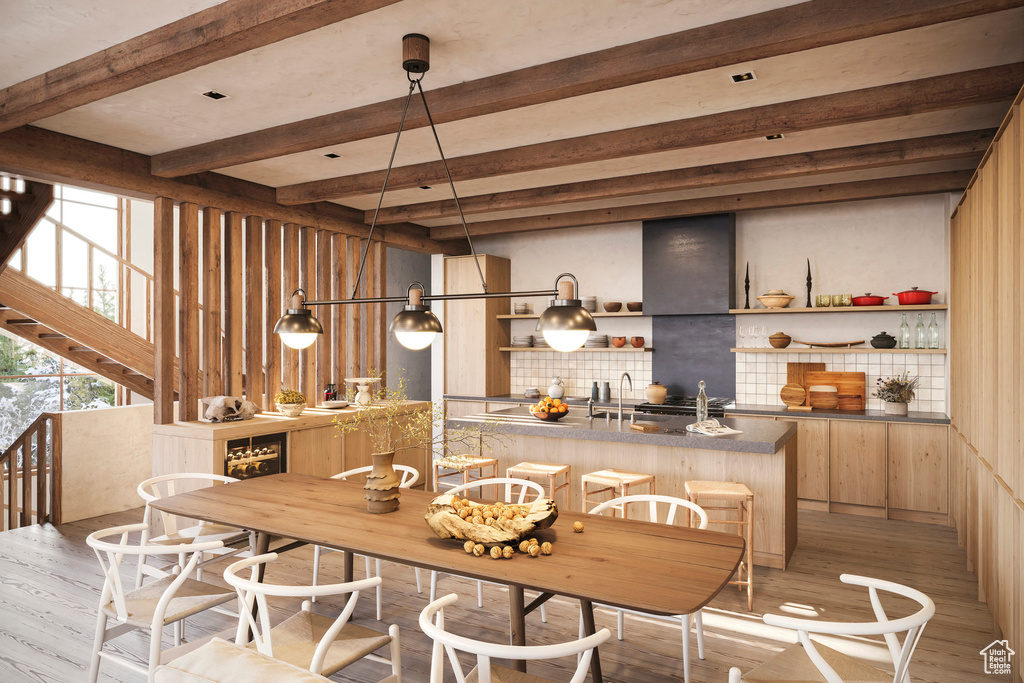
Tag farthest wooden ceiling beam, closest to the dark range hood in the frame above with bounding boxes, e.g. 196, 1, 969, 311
430, 171, 973, 240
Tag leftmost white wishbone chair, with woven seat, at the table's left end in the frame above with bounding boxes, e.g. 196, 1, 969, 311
86, 523, 234, 683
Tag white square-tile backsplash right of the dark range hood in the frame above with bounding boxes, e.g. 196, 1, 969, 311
737, 351, 946, 413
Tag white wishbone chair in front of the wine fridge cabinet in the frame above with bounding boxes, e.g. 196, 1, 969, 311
135, 472, 256, 588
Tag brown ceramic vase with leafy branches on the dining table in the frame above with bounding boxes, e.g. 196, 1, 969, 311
334, 373, 501, 513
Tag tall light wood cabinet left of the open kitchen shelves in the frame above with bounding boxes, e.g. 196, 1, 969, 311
443, 255, 512, 396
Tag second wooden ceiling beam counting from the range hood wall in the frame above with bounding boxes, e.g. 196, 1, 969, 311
364, 128, 996, 225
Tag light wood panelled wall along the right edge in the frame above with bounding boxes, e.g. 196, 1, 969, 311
948, 90, 1024, 682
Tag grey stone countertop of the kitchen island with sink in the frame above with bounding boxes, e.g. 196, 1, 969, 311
446, 408, 797, 455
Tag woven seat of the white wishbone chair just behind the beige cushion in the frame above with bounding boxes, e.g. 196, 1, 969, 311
249, 611, 391, 676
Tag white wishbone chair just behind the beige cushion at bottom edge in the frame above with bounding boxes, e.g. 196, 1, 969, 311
224, 553, 401, 683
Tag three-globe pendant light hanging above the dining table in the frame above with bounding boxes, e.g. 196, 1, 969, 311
273, 33, 597, 352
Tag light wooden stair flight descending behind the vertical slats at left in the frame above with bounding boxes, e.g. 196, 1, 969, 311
0, 269, 177, 398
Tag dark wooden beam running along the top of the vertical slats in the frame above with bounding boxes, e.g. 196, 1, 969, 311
0, 126, 469, 255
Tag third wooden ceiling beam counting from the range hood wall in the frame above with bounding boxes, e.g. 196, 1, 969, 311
278, 62, 1024, 205
